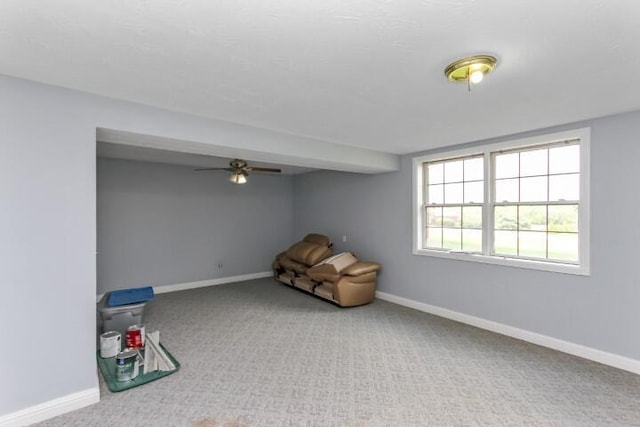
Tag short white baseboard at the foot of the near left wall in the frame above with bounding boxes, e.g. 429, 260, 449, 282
0, 387, 100, 427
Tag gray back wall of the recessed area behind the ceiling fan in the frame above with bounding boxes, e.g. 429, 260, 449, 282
98, 159, 293, 293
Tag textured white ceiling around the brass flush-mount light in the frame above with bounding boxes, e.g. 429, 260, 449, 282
0, 0, 640, 153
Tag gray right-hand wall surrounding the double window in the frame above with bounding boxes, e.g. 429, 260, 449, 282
294, 112, 640, 359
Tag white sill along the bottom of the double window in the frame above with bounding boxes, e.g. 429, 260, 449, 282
413, 249, 590, 276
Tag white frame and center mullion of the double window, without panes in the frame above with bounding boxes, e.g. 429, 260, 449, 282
412, 127, 591, 276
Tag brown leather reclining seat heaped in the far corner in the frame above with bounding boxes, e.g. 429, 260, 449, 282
273, 234, 380, 307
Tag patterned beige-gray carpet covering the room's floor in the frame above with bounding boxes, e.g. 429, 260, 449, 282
40, 279, 640, 427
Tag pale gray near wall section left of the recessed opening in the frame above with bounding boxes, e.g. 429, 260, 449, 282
0, 79, 98, 415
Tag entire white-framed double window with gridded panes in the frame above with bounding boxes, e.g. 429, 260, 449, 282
414, 128, 589, 274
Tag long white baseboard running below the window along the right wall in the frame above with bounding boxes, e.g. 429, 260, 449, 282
376, 291, 640, 374
